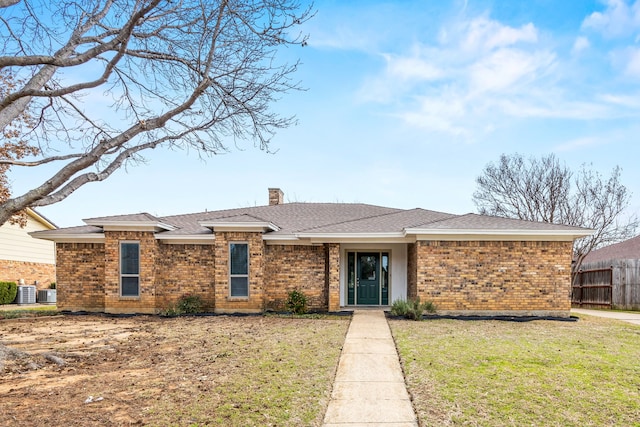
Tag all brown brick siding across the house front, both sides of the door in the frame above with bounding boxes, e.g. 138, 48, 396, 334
57, 231, 571, 313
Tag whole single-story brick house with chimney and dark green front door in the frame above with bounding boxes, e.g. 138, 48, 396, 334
33, 188, 590, 316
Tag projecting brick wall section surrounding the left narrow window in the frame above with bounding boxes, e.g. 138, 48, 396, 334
104, 231, 159, 313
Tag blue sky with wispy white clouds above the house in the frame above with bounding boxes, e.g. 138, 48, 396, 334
14, 0, 640, 226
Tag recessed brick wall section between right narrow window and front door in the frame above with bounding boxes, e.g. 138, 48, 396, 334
264, 245, 328, 311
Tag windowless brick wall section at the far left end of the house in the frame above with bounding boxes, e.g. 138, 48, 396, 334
56, 243, 105, 312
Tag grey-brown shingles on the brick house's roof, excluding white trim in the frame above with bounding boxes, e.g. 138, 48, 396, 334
32, 203, 585, 238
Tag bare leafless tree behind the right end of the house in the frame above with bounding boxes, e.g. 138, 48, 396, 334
473, 154, 638, 272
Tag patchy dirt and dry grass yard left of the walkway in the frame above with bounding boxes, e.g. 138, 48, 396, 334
0, 316, 348, 426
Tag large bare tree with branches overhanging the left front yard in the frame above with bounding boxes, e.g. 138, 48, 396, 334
0, 0, 312, 224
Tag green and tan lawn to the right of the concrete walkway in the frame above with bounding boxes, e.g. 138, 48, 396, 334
390, 316, 640, 426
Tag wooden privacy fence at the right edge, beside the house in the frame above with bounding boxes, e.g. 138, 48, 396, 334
571, 259, 640, 310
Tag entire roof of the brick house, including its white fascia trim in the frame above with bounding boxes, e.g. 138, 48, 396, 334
28, 196, 591, 243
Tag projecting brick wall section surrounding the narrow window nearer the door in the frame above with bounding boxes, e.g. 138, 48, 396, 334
214, 232, 265, 312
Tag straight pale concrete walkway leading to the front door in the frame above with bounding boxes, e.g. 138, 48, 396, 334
323, 310, 418, 427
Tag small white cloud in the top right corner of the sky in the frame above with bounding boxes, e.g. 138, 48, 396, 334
582, 0, 640, 38
